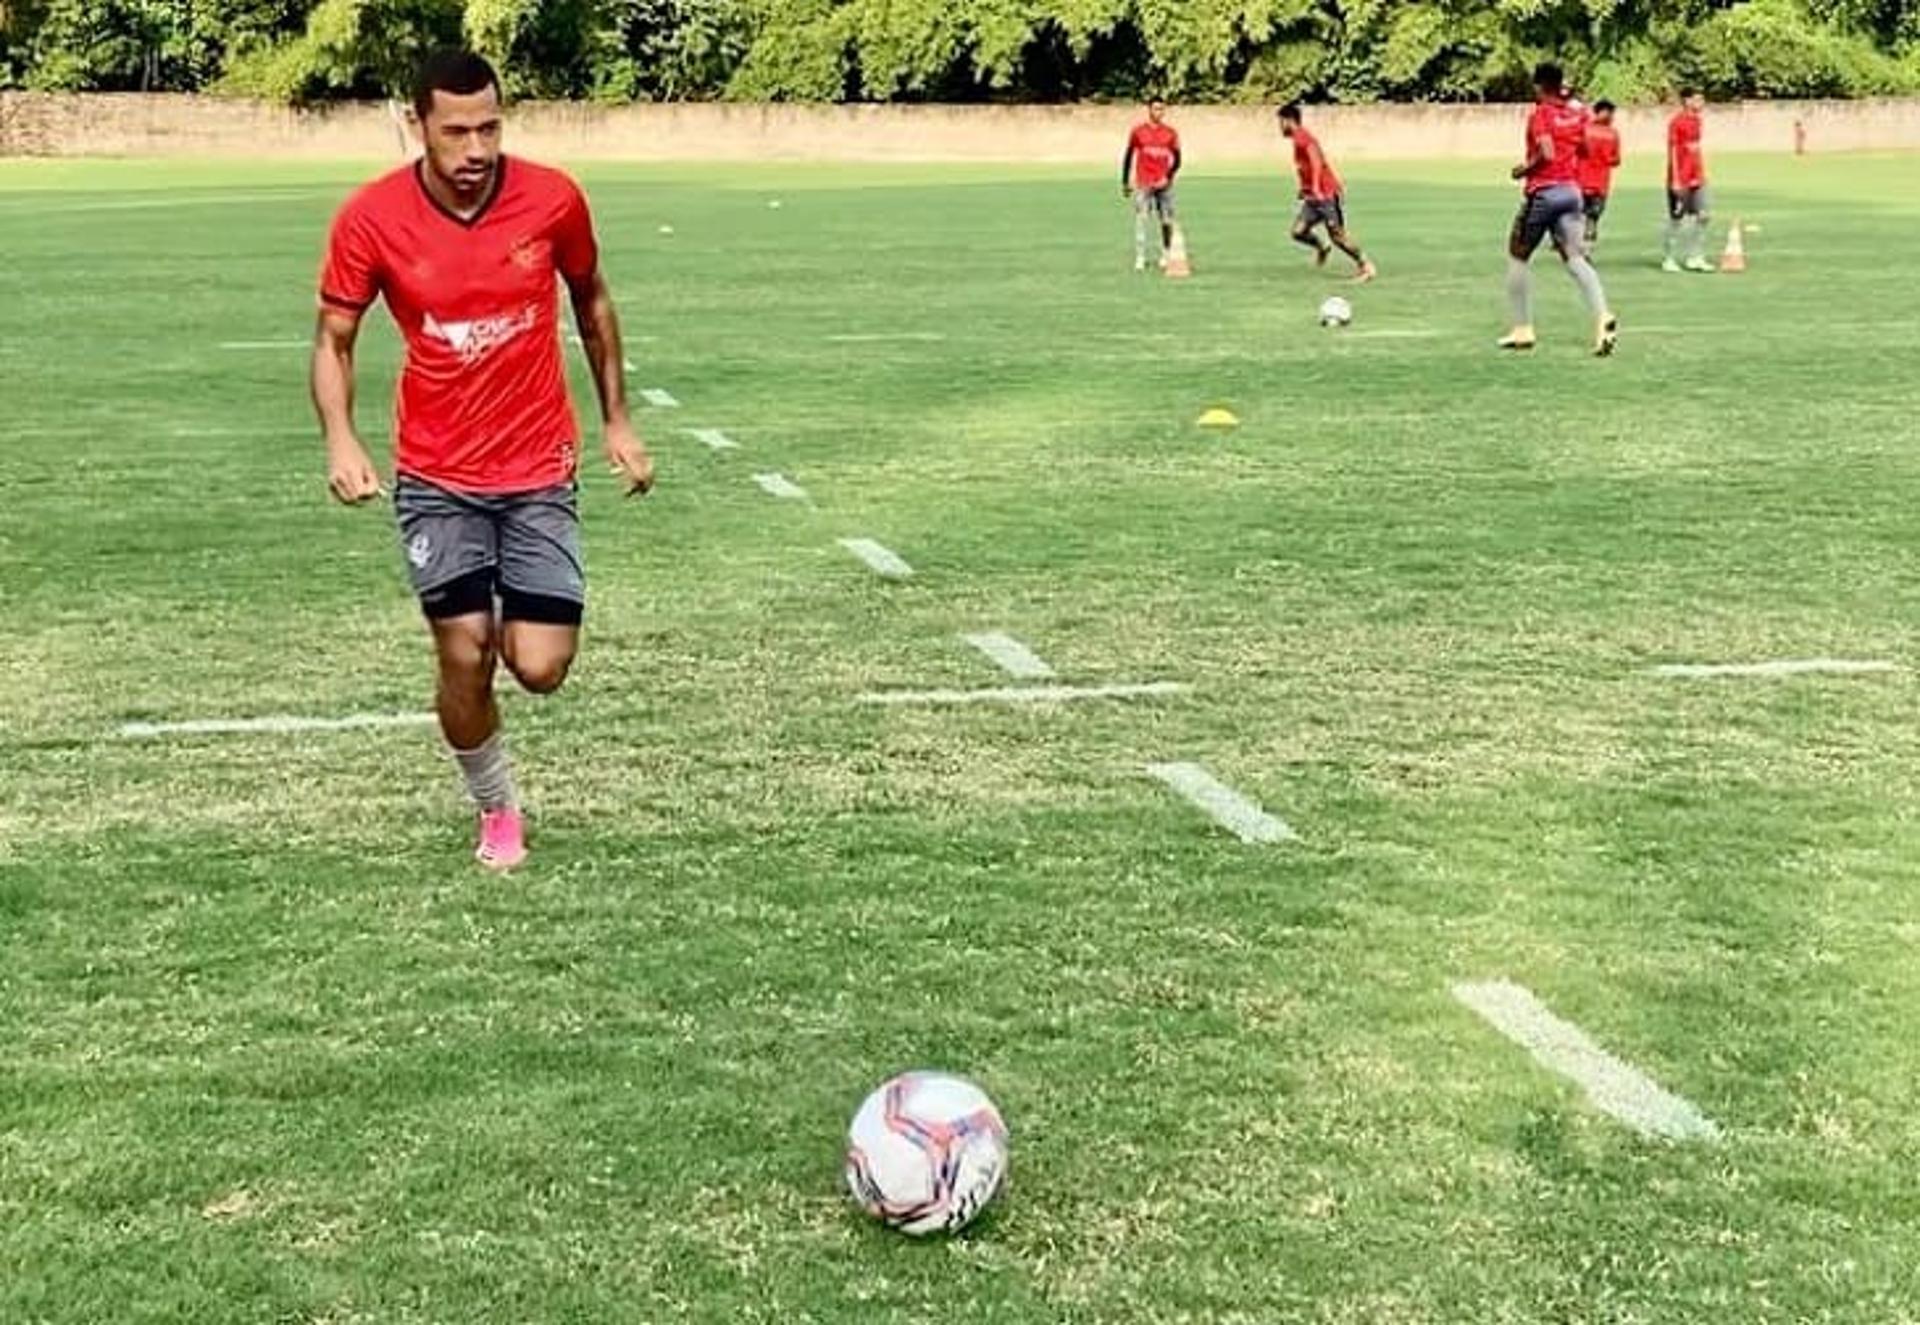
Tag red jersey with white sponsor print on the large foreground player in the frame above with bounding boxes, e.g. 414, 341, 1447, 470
321, 156, 599, 492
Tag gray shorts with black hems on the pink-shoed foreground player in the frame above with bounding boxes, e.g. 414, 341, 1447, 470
394, 474, 586, 624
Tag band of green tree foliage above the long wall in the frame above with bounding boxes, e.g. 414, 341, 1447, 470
0, 0, 1920, 102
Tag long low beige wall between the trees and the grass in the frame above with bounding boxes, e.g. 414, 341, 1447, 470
0, 92, 1920, 165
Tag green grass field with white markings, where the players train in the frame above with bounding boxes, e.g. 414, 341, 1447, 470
0, 144, 1920, 1323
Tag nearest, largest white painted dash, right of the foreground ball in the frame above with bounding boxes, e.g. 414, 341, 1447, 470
1453, 979, 1720, 1141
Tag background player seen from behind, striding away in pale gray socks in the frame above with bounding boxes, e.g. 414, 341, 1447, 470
1500, 63, 1620, 357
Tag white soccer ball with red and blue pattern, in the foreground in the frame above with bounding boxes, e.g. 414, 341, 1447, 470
847, 1072, 1008, 1237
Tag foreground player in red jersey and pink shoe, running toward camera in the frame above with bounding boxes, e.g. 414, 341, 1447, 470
313, 52, 653, 870
